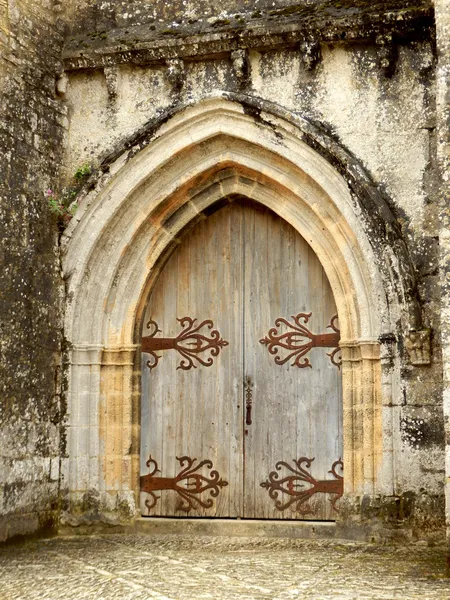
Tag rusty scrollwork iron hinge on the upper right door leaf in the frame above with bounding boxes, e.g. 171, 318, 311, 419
259, 313, 342, 369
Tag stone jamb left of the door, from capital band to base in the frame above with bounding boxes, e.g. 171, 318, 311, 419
63, 344, 139, 525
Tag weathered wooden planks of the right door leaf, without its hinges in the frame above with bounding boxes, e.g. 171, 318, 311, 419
244, 206, 342, 519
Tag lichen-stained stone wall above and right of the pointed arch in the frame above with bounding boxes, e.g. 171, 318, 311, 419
57, 2, 444, 544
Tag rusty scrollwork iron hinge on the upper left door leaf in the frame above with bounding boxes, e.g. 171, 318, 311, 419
142, 317, 228, 371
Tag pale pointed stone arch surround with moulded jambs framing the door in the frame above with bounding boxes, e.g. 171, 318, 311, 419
63, 96, 411, 524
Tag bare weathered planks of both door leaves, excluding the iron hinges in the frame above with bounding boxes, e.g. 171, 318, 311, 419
141, 202, 342, 519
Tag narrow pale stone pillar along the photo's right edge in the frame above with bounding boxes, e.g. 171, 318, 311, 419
435, 0, 450, 565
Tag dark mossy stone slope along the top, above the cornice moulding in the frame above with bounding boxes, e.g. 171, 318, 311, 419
61, 0, 432, 35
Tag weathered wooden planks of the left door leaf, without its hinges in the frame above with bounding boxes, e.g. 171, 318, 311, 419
141, 207, 242, 517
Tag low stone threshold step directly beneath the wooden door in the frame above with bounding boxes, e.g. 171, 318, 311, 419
134, 517, 337, 539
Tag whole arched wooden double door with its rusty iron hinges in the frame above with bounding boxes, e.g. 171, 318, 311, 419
141, 201, 343, 520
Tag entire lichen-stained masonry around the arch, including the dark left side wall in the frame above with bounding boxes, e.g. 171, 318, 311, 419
0, 0, 450, 539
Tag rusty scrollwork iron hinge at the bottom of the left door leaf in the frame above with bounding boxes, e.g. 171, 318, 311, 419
140, 455, 228, 514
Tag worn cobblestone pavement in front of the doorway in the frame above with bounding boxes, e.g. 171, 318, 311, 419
0, 535, 450, 600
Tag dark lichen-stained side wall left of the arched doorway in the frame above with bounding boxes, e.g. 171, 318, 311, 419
0, 0, 65, 541
